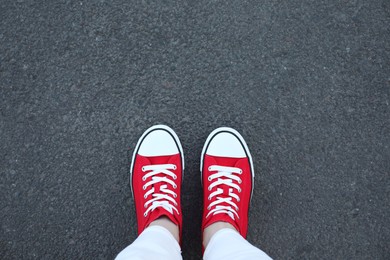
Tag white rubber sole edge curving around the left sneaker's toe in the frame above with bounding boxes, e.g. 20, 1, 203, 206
130, 125, 185, 198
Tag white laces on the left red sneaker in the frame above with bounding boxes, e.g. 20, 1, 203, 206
142, 164, 179, 217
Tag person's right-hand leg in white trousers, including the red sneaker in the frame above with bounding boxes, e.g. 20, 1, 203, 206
200, 127, 270, 259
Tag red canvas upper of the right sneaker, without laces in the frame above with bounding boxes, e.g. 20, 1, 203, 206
202, 154, 253, 237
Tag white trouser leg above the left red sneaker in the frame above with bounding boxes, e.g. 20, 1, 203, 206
115, 226, 182, 260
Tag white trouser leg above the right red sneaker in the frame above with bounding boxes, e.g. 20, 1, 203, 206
203, 228, 271, 260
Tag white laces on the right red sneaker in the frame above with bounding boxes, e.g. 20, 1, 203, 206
206, 165, 242, 220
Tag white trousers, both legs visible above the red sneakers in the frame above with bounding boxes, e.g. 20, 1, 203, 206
116, 226, 271, 260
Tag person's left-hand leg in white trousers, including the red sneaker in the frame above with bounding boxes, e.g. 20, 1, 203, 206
117, 125, 184, 259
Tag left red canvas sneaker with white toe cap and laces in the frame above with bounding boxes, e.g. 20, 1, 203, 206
130, 125, 184, 237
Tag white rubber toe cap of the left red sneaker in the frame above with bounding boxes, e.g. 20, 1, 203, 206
138, 128, 179, 156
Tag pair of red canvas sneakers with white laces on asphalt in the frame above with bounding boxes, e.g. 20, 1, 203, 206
130, 125, 254, 243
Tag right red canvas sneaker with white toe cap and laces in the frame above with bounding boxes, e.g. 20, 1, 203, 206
200, 127, 254, 238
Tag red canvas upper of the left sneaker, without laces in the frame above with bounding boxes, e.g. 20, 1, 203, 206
132, 154, 183, 240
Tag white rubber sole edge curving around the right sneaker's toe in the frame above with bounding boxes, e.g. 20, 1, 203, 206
200, 127, 255, 199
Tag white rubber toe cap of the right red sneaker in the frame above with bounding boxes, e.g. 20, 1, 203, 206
205, 129, 247, 158
